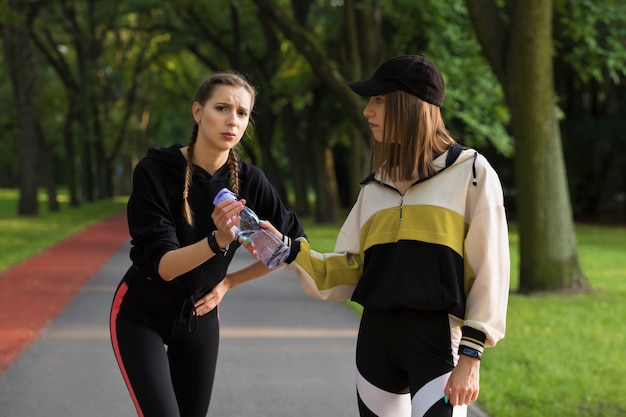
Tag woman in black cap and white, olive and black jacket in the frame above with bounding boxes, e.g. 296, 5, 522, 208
258, 55, 509, 417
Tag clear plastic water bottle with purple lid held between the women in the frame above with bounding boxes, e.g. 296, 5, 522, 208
213, 188, 290, 269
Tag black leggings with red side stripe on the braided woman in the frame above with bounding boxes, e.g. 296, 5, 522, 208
110, 284, 219, 417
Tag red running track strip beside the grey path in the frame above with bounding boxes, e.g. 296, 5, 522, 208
0, 212, 130, 373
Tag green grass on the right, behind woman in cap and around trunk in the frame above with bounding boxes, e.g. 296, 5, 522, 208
305, 218, 626, 417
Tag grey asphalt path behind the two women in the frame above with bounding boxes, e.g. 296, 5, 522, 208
0, 245, 484, 417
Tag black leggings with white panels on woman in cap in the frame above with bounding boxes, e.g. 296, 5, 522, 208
356, 309, 465, 417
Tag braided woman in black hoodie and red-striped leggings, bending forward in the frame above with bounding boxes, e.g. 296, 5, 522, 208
110, 73, 304, 417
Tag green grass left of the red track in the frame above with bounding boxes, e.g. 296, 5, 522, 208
0, 189, 127, 271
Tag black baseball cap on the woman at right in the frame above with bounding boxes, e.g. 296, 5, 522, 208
348, 55, 445, 107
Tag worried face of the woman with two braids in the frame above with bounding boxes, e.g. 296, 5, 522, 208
192, 85, 252, 151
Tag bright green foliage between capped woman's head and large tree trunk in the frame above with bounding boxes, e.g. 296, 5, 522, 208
385, 0, 513, 156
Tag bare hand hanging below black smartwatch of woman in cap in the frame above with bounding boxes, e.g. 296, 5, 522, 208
444, 355, 480, 405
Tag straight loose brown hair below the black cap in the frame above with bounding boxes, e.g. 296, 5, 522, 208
371, 90, 455, 181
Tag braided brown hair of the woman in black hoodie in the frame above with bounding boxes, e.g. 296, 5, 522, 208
183, 72, 256, 225
